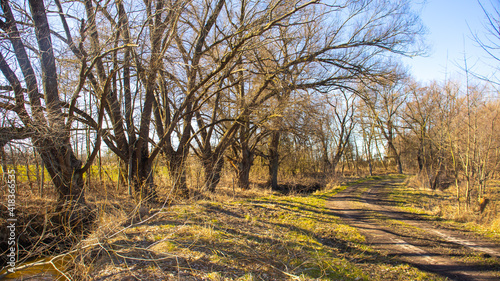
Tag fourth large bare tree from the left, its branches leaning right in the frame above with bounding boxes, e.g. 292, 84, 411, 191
177, 1, 326, 190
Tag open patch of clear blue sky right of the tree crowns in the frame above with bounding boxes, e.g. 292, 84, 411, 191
404, 0, 496, 83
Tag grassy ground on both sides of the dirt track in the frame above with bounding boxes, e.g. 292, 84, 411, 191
0, 168, 500, 280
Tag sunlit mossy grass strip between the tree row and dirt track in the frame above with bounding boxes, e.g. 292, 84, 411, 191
64, 178, 439, 280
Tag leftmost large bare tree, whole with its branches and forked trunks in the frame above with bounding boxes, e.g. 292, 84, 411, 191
0, 1, 99, 211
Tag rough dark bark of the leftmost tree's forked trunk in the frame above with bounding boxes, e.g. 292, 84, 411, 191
23, 0, 85, 207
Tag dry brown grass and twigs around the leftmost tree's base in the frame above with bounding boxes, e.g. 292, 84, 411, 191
0, 178, 136, 280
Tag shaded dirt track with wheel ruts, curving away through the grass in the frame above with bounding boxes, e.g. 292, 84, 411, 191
327, 179, 500, 280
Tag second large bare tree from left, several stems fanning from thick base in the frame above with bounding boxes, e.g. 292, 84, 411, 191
56, 0, 184, 201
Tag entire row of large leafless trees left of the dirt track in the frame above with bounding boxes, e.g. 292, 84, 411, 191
1, 0, 421, 203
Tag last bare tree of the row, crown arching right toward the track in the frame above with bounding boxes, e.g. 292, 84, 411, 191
256, 1, 421, 187
